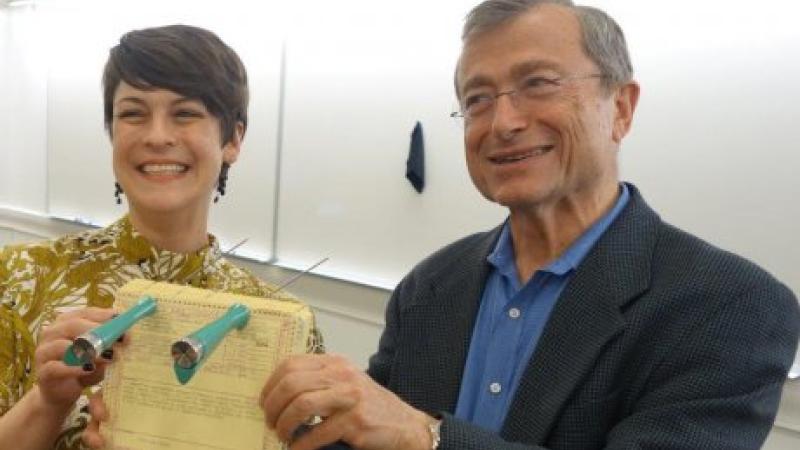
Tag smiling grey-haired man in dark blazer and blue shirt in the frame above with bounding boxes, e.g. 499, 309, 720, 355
262, 0, 799, 450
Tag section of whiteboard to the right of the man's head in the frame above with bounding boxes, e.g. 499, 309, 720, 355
592, 0, 800, 293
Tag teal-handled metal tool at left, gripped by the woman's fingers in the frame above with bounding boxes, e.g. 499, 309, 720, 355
64, 295, 156, 366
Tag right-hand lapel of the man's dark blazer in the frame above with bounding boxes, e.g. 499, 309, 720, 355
502, 185, 660, 442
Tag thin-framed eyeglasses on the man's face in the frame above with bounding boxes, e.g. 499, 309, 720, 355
450, 73, 606, 123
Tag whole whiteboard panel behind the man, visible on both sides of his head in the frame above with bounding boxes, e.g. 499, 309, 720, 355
277, 0, 800, 292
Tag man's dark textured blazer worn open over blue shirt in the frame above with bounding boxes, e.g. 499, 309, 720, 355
368, 186, 800, 450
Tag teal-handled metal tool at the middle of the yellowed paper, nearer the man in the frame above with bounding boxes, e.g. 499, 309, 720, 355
171, 303, 250, 384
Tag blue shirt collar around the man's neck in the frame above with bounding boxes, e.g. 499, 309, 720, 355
486, 183, 630, 280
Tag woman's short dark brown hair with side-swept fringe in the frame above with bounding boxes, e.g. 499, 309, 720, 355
103, 25, 249, 145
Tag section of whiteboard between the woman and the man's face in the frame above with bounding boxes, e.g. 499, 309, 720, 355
277, 0, 505, 288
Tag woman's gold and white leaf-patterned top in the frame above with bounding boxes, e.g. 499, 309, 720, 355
0, 216, 322, 449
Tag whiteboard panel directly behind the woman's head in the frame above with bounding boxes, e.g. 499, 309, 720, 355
43, 0, 283, 260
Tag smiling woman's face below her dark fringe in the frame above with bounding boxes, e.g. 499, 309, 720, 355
111, 81, 242, 220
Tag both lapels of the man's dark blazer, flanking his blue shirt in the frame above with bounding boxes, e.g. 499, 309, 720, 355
418, 184, 661, 442
